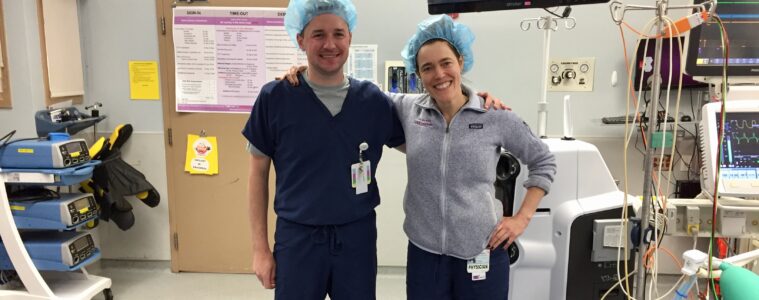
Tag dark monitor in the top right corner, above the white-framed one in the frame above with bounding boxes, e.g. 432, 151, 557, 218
685, 0, 759, 77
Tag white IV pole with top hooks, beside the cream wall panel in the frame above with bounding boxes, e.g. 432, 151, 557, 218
519, 15, 577, 139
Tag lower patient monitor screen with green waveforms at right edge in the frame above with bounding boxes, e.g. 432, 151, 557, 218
717, 112, 759, 179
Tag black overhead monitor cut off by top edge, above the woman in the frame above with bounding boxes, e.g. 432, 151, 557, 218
427, 0, 610, 15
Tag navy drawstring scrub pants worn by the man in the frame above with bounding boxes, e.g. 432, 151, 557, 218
274, 211, 377, 300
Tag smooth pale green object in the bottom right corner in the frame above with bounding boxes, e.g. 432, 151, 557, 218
719, 262, 759, 300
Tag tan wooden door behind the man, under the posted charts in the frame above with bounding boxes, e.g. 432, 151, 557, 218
156, 0, 287, 273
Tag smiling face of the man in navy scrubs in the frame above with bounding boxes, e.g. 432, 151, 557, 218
298, 14, 351, 76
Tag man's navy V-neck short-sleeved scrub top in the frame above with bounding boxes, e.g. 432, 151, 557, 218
242, 77, 405, 225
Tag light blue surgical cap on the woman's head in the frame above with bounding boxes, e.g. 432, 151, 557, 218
401, 15, 474, 73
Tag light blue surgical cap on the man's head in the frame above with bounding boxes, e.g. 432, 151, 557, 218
285, 0, 356, 47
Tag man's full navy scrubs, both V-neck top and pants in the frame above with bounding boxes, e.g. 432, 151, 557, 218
243, 77, 404, 300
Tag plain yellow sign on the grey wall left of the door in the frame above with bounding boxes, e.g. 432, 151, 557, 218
129, 60, 161, 100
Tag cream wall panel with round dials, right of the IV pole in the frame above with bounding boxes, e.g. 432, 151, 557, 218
547, 57, 596, 92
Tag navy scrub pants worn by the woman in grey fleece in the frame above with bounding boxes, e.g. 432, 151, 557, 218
406, 242, 509, 300
